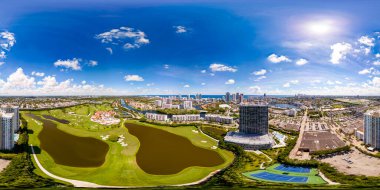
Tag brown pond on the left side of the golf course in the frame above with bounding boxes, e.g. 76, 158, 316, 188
27, 114, 109, 167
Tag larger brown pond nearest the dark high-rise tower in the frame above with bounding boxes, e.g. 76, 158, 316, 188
125, 123, 224, 175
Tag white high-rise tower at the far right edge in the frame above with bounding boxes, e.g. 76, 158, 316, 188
364, 110, 380, 149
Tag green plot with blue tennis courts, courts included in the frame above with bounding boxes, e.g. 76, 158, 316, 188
243, 164, 326, 184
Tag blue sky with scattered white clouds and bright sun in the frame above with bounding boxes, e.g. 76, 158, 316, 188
0, 0, 380, 96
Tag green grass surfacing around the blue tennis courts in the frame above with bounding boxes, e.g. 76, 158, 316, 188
243, 164, 326, 184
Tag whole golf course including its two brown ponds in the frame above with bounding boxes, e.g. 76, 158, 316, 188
21, 104, 234, 187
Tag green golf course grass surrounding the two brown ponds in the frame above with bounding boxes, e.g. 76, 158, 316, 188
22, 105, 234, 186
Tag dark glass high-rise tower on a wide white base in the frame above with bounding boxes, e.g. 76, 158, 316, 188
239, 105, 269, 135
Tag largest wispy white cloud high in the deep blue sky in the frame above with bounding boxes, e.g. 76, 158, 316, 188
95, 27, 150, 50
